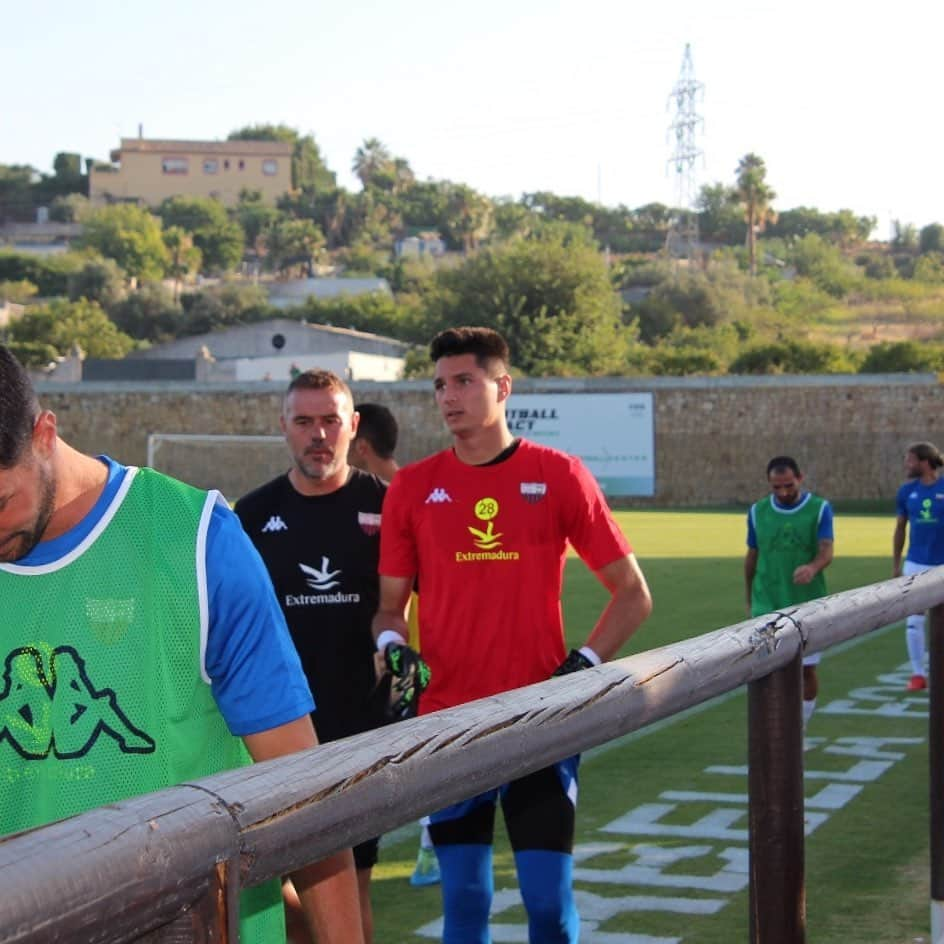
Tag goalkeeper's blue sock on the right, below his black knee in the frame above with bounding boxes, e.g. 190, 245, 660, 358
515, 849, 580, 944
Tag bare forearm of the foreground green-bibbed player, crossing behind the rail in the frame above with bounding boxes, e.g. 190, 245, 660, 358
243, 715, 364, 944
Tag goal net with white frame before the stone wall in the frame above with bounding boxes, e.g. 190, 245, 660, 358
147, 433, 290, 502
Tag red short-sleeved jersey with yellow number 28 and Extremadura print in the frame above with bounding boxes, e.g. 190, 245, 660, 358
380, 440, 630, 714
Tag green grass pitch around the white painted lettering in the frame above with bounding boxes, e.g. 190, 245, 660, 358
373, 511, 929, 944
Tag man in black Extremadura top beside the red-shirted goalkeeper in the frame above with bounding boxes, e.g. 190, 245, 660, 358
236, 370, 386, 944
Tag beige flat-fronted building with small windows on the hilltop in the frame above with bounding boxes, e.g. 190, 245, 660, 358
89, 138, 292, 206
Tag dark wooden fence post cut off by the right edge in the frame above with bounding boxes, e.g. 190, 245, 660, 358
928, 604, 944, 944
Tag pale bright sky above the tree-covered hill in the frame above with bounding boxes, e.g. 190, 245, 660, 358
0, 0, 944, 239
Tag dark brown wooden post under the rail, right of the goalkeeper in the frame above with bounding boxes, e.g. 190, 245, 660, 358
747, 650, 806, 944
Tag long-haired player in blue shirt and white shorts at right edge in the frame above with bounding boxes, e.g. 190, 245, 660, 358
892, 442, 944, 692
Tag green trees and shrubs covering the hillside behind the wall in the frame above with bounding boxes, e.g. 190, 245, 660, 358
0, 140, 944, 376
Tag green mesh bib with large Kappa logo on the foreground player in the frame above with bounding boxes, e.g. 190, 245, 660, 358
0, 469, 284, 944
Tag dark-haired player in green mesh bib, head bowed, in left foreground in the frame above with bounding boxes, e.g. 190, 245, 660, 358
0, 345, 362, 944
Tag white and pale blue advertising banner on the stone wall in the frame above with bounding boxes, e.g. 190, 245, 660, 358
507, 393, 656, 496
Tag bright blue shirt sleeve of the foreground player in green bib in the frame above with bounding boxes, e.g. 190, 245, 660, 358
206, 505, 314, 736
